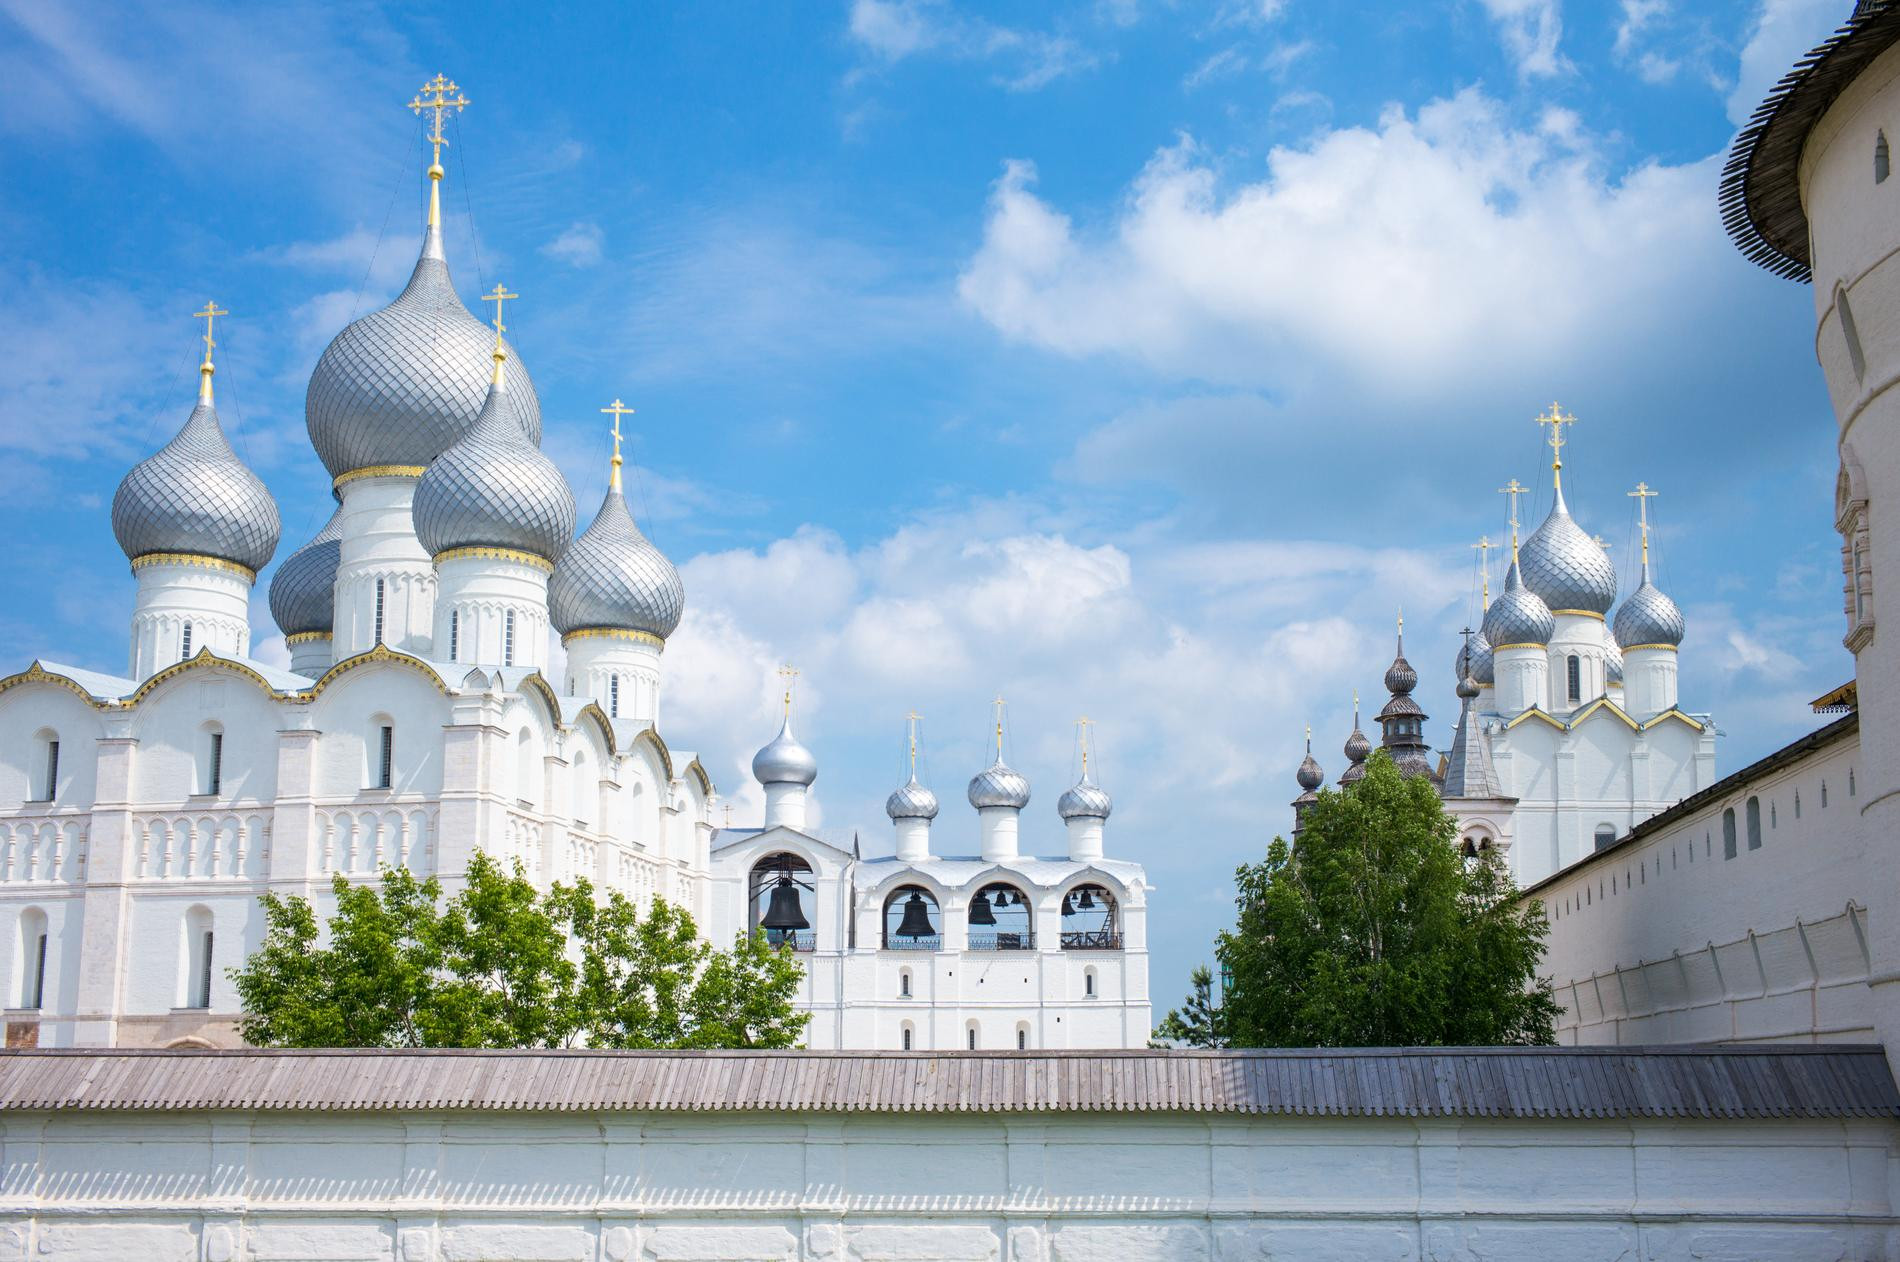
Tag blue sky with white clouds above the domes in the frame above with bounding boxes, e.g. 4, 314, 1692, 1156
0, 0, 1851, 1009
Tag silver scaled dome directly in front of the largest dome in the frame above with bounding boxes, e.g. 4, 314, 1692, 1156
414, 364, 574, 564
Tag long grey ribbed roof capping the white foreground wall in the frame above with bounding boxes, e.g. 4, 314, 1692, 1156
0, 1045, 1900, 1118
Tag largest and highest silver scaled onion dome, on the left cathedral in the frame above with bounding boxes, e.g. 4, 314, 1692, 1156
304, 226, 542, 477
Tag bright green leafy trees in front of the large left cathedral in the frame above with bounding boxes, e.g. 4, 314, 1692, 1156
230, 853, 809, 1047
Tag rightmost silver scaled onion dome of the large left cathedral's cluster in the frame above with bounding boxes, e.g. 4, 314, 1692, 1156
547, 487, 686, 639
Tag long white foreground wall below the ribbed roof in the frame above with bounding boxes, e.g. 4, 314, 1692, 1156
0, 1112, 1900, 1262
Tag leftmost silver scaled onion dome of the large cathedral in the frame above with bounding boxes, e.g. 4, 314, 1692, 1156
112, 399, 283, 570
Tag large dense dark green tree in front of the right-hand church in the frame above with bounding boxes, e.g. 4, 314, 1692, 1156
1163, 751, 1558, 1047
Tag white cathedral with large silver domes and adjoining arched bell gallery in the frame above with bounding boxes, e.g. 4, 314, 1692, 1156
0, 76, 1150, 1049
